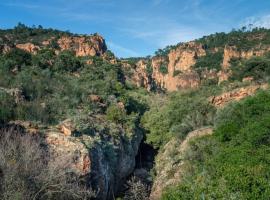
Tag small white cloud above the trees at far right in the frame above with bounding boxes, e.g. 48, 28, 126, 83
240, 14, 270, 28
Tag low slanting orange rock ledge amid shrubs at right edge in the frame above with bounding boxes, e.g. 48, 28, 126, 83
209, 84, 268, 107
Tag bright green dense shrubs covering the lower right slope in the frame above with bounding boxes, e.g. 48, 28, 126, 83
163, 91, 270, 199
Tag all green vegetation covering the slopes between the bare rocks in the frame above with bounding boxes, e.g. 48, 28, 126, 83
0, 24, 270, 200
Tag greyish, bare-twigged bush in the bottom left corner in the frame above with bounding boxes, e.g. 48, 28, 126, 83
0, 128, 95, 200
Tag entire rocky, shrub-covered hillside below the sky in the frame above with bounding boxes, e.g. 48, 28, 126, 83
0, 24, 270, 200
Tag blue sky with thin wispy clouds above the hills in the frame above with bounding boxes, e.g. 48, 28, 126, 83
0, 0, 270, 57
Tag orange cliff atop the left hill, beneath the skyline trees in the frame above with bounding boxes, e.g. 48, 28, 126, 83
57, 35, 107, 56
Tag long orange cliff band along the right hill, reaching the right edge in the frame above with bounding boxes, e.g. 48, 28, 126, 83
128, 38, 270, 91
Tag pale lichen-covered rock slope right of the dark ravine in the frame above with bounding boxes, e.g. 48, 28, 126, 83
150, 127, 213, 200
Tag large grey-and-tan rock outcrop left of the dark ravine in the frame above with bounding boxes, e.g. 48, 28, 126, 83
11, 120, 143, 200
